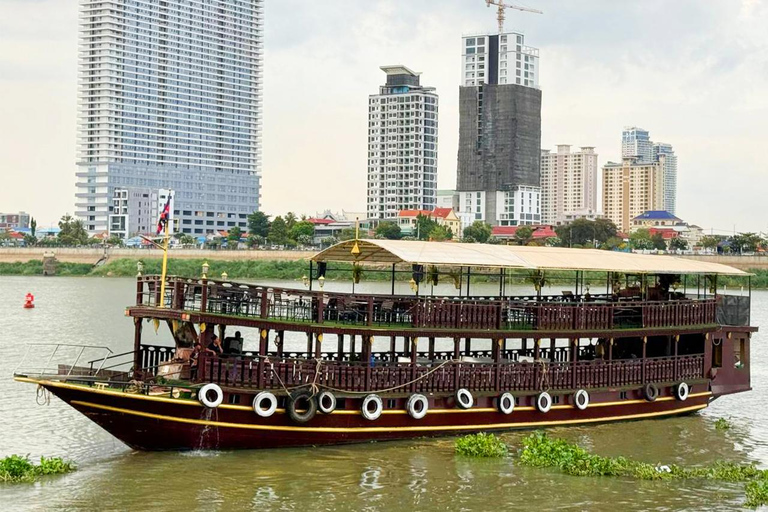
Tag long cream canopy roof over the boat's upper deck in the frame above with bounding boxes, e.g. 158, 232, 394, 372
312, 240, 749, 276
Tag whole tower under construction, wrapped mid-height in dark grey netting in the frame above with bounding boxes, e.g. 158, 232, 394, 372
456, 32, 541, 226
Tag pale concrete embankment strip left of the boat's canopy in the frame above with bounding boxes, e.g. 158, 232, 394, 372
0, 247, 314, 265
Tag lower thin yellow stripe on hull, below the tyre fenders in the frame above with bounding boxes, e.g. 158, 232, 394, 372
72, 400, 707, 433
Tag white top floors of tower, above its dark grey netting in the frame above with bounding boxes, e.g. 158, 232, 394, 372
461, 32, 539, 88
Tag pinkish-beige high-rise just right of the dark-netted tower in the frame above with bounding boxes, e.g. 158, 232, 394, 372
541, 144, 597, 224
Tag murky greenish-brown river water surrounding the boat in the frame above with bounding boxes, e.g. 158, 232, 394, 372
0, 277, 768, 511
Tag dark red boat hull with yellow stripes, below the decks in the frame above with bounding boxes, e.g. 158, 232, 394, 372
17, 378, 712, 450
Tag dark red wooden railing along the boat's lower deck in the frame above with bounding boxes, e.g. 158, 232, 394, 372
197, 354, 704, 393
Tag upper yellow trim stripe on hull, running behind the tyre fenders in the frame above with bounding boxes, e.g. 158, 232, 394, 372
14, 377, 712, 415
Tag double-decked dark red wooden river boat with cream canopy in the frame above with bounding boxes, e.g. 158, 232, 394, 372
14, 238, 757, 450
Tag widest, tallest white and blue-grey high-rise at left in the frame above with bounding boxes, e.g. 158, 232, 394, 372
75, 0, 263, 235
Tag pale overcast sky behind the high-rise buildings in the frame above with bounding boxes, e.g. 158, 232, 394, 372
0, 0, 768, 233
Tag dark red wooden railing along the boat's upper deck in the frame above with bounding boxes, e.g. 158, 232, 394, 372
136, 276, 717, 331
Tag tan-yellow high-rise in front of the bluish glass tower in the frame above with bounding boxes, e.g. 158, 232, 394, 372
603, 155, 665, 233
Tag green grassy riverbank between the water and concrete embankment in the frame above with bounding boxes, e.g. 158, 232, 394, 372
0, 258, 768, 293
